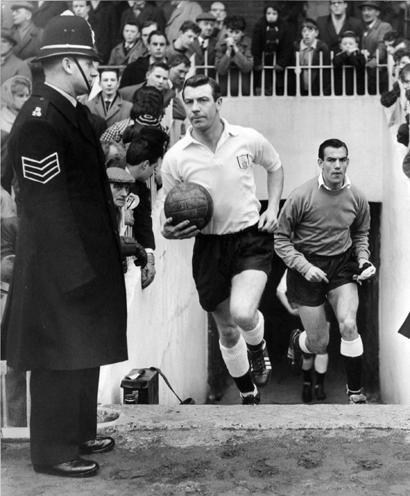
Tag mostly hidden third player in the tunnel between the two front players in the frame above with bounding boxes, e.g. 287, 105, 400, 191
276, 270, 329, 403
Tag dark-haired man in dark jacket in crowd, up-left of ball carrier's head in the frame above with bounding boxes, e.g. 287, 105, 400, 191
120, 31, 167, 88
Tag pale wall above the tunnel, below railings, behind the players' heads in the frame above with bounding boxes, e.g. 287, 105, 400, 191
222, 96, 385, 202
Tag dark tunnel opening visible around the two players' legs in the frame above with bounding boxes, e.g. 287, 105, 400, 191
208, 202, 381, 404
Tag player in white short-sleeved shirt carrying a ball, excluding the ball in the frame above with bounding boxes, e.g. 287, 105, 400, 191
162, 74, 283, 405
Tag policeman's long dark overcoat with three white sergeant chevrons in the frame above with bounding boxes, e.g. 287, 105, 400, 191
4, 85, 127, 370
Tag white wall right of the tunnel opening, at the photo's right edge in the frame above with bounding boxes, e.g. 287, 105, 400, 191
380, 128, 410, 405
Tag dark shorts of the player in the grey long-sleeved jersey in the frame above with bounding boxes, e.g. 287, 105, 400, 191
286, 249, 358, 307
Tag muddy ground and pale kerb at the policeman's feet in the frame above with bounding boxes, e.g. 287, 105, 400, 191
1, 404, 410, 496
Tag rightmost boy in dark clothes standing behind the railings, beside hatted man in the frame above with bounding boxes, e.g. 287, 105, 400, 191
333, 31, 366, 95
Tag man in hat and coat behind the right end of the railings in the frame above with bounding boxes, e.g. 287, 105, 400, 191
360, 2, 392, 94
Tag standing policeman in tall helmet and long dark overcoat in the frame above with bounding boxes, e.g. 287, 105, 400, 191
4, 15, 127, 477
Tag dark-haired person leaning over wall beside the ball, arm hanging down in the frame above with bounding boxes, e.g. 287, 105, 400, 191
121, 127, 168, 289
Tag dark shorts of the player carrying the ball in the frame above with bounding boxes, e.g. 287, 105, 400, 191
192, 225, 273, 312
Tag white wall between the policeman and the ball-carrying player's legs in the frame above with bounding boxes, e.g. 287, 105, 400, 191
99, 199, 208, 405
